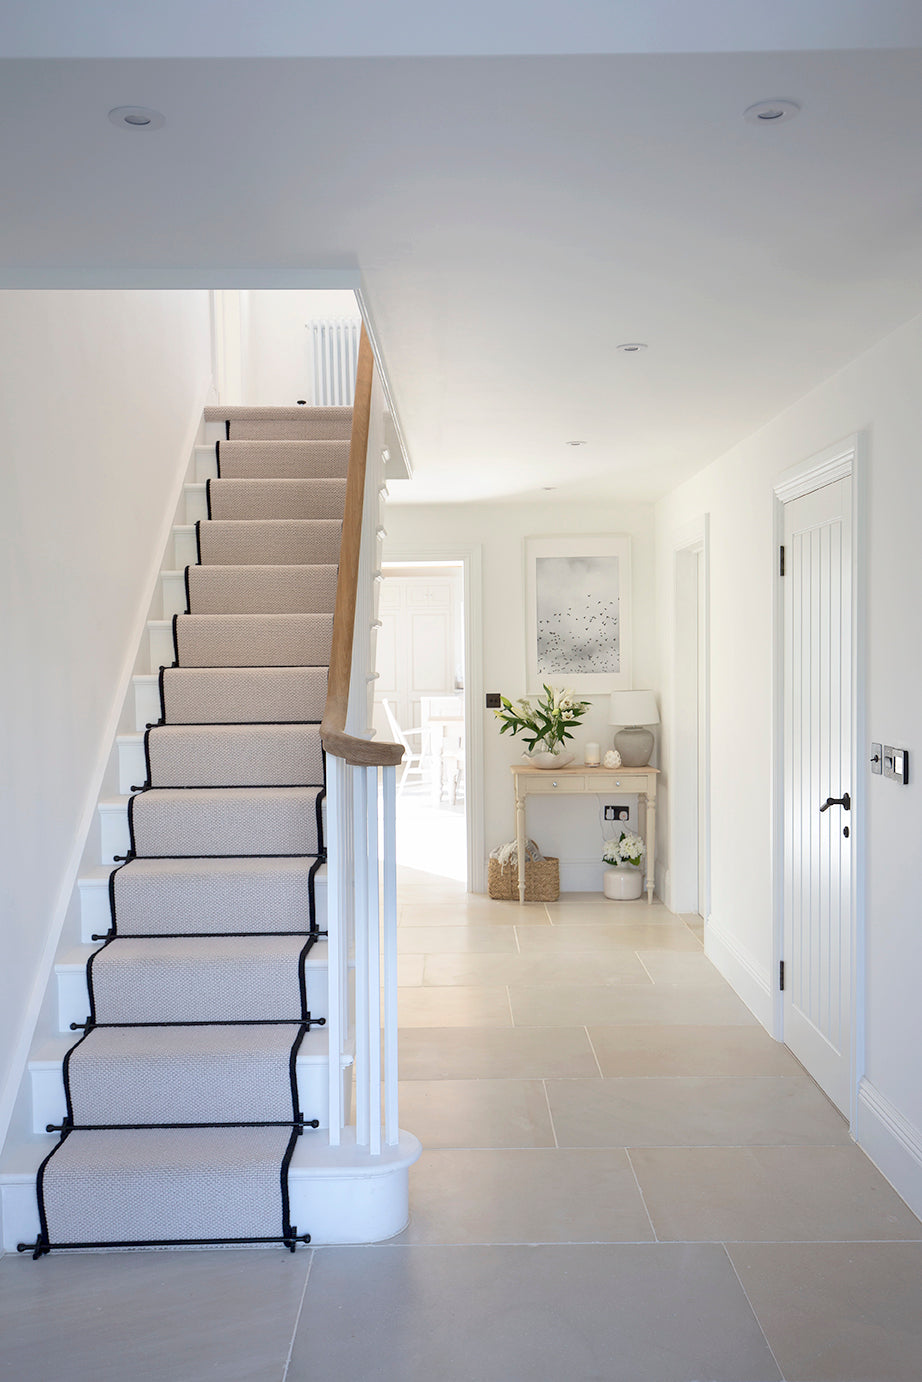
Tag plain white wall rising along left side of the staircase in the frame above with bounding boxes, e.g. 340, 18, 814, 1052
0, 292, 211, 1133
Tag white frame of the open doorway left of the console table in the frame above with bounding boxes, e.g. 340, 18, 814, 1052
384, 542, 487, 893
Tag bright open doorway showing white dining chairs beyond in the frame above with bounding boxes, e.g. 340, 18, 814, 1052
375, 561, 470, 886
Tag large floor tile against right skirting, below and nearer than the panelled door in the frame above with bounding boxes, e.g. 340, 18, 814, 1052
630, 1146, 922, 1242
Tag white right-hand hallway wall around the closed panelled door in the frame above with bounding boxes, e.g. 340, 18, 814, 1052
657, 310, 922, 1212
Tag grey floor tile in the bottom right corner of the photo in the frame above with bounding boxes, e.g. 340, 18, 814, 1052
728, 1242, 922, 1382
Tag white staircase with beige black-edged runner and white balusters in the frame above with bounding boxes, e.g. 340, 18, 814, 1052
0, 331, 419, 1256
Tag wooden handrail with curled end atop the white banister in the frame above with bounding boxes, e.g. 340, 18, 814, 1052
321, 326, 404, 768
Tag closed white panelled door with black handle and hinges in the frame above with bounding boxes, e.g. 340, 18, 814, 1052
784, 480, 853, 1117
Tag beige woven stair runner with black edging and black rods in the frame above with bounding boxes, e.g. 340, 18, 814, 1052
27, 408, 351, 1256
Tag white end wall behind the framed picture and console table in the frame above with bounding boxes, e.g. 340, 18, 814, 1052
384, 496, 657, 891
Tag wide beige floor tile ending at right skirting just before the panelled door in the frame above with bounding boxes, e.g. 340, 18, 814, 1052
511, 984, 756, 1027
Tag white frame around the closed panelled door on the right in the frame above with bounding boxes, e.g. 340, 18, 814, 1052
771, 433, 867, 1136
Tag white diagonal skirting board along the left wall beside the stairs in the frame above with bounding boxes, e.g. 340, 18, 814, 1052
0, 401, 205, 1147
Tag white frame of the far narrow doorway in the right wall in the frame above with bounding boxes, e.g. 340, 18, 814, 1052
659, 514, 711, 915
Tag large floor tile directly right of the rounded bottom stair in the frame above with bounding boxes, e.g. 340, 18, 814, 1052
395, 1148, 654, 1244
